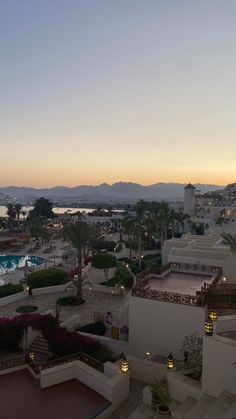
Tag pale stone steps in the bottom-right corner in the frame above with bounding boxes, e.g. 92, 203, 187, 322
172, 391, 236, 419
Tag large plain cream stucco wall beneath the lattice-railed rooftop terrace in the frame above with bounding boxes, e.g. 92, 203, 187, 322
129, 297, 205, 359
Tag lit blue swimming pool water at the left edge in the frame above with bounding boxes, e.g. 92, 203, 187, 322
0, 255, 44, 274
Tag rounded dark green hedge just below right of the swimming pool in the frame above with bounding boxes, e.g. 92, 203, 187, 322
27, 268, 68, 288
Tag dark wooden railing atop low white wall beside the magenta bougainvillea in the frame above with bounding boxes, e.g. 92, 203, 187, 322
27, 352, 104, 374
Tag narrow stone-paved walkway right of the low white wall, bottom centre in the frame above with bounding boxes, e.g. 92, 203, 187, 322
107, 380, 147, 419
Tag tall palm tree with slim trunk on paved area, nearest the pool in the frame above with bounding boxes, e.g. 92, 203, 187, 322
65, 220, 91, 304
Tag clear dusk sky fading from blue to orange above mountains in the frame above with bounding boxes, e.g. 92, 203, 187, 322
0, 0, 236, 187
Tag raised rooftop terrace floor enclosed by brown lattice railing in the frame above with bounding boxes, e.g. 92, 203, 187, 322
149, 272, 212, 295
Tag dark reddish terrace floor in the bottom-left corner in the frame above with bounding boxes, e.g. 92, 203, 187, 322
0, 370, 108, 419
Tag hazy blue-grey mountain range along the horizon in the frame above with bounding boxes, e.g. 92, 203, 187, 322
0, 182, 222, 202
